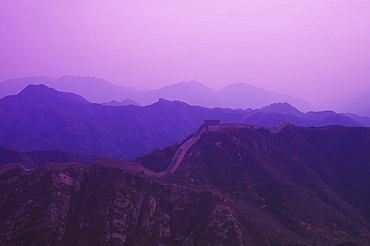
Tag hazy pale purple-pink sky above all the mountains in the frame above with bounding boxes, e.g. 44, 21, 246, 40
0, 0, 370, 109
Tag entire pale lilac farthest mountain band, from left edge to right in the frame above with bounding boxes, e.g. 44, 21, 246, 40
0, 76, 313, 111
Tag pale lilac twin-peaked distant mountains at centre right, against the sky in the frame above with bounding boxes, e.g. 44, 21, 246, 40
125, 81, 313, 111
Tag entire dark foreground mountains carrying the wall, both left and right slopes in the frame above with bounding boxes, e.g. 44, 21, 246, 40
0, 124, 370, 245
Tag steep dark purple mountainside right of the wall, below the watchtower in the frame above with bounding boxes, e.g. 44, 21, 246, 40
136, 125, 370, 245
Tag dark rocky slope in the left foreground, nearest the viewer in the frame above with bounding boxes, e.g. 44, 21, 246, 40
0, 164, 307, 245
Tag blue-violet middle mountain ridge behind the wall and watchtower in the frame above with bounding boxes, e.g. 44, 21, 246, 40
0, 85, 365, 160
